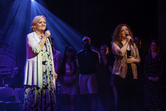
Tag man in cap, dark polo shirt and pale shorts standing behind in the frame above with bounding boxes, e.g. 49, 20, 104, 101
77, 37, 100, 111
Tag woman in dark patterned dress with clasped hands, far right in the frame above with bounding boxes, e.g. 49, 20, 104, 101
144, 40, 166, 111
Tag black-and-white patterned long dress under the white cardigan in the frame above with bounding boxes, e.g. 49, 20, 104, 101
23, 40, 56, 111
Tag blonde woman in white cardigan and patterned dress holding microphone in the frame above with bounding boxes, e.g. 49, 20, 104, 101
23, 15, 57, 111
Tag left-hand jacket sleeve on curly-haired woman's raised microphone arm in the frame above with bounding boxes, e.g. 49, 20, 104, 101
112, 42, 124, 57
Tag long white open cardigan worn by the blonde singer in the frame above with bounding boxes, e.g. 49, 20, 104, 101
24, 32, 55, 88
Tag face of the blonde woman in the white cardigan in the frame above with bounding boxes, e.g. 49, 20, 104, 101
36, 18, 46, 31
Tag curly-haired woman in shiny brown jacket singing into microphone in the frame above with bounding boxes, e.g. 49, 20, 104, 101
112, 24, 140, 111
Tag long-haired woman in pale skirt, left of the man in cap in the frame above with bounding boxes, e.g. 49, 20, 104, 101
60, 47, 79, 111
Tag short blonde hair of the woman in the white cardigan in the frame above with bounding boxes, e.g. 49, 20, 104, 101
31, 15, 46, 32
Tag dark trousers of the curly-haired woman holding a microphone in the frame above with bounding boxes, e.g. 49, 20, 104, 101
113, 74, 136, 111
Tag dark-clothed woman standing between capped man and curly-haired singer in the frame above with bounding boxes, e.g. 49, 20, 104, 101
98, 44, 115, 111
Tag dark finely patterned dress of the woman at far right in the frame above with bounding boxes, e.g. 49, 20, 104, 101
144, 54, 166, 109
